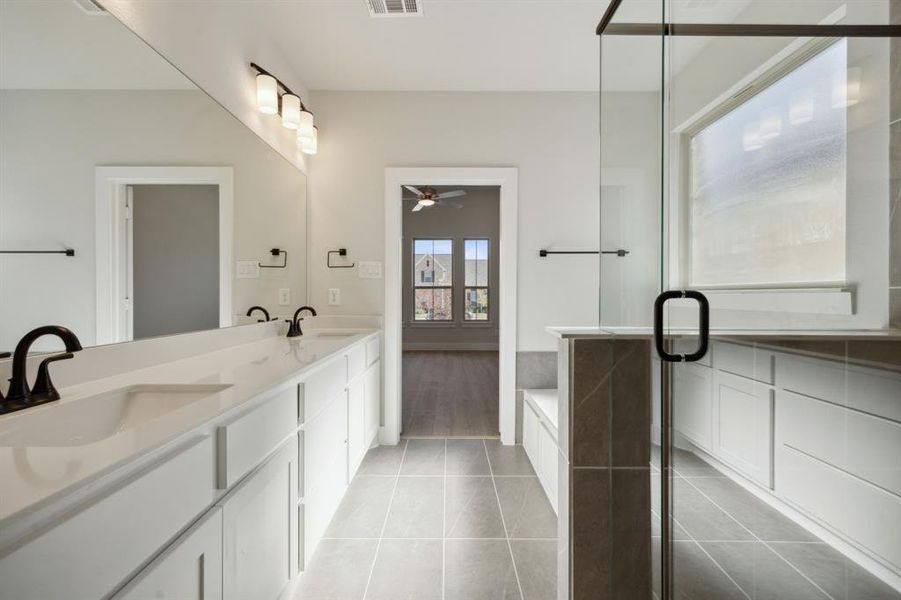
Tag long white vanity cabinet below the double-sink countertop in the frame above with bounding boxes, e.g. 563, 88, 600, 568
0, 335, 381, 600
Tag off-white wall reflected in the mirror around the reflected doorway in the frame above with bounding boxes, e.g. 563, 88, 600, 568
0, 90, 306, 350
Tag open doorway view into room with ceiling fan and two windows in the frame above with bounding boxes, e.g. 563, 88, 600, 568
401, 185, 500, 437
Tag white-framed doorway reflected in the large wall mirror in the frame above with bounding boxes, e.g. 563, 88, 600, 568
95, 167, 233, 344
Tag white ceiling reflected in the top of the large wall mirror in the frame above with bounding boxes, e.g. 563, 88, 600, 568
0, 0, 196, 90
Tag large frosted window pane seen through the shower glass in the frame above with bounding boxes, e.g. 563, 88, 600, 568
687, 40, 859, 288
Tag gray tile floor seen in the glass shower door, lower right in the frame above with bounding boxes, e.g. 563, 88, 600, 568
651, 450, 901, 600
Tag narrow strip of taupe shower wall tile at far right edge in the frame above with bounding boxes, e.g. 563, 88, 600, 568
889, 0, 901, 327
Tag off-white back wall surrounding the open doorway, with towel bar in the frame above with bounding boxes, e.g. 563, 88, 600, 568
309, 92, 657, 351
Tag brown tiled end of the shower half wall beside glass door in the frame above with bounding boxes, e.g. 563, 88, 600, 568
564, 339, 651, 600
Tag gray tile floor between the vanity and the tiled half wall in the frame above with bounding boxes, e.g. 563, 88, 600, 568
295, 439, 557, 600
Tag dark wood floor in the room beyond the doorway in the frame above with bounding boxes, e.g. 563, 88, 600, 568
402, 351, 499, 437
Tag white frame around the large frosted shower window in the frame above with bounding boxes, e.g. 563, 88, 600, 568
671, 37, 850, 292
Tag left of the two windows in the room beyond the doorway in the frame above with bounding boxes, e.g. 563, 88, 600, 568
413, 239, 454, 321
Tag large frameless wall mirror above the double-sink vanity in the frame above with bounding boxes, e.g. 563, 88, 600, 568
0, 0, 307, 352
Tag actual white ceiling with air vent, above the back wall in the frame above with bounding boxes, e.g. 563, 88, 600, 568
103, 0, 750, 91
